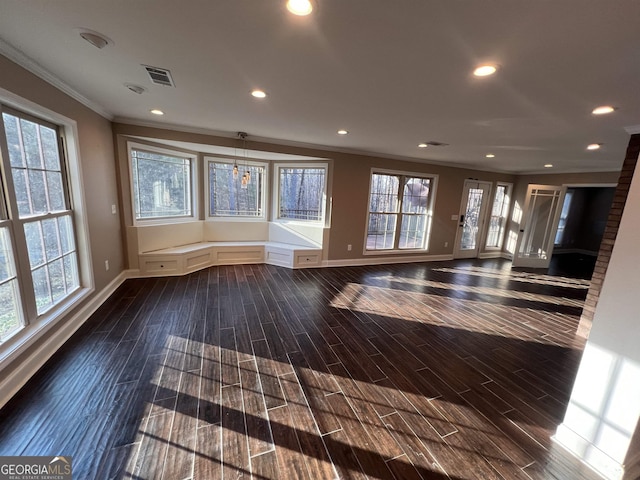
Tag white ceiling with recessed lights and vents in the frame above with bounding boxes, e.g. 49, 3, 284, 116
0, 0, 640, 172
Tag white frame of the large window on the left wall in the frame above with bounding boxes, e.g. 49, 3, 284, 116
0, 88, 95, 364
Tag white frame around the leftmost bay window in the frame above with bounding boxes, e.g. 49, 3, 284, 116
127, 142, 199, 226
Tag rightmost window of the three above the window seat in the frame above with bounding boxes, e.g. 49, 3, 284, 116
276, 165, 327, 222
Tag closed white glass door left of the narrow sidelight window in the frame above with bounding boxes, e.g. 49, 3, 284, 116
453, 180, 491, 258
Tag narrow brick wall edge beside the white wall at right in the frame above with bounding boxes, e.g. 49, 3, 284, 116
578, 134, 640, 337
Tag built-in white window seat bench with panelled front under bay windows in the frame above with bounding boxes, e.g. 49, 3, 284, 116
133, 222, 322, 276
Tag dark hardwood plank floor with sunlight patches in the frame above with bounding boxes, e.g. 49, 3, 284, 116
0, 260, 604, 480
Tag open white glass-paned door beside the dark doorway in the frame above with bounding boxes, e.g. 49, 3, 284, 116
513, 185, 566, 268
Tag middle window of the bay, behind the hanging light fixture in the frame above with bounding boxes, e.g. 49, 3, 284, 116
207, 158, 266, 219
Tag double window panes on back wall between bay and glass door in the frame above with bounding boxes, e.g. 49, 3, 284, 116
366, 172, 435, 250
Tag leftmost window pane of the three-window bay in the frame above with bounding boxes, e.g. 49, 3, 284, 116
130, 146, 195, 220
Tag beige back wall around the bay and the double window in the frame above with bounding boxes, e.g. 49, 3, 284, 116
113, 123, 516, 260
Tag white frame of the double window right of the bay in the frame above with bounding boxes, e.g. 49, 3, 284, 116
362, 168, 438, 255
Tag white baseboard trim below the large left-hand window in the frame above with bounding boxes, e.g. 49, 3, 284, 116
0, 270, 131, 408
